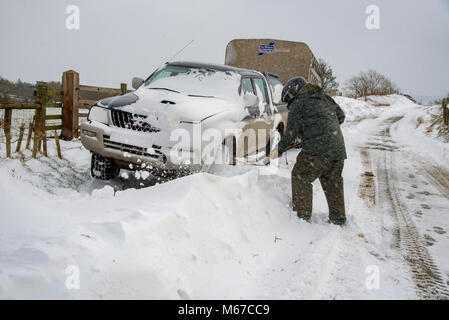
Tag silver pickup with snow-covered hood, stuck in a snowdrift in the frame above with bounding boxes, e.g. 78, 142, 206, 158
81, 62, 287, 180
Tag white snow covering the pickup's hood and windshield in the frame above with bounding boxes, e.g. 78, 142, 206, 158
98, 68, 243, 127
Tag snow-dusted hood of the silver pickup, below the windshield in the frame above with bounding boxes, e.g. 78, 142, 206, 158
97, 88, 235, 122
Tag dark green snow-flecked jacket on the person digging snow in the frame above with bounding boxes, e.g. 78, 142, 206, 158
278, 83, 346, 160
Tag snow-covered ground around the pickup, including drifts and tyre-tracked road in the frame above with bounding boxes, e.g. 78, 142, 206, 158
0, 95, 449, 299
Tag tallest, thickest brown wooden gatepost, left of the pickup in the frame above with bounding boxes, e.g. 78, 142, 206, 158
61, 70, 80, 140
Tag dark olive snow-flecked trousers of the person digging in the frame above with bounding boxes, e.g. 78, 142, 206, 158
292, 155, 346, 222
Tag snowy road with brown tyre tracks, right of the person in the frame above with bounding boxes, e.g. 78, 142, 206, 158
344, 108, 449, 299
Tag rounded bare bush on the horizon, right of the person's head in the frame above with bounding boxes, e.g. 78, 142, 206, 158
345, 70, 399, 98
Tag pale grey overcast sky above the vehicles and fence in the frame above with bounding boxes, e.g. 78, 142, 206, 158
0, 0, 449, 100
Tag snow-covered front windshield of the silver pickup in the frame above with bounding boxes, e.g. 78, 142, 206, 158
144, 65, 240, 98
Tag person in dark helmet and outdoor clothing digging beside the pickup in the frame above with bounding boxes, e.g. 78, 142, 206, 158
278, 77, 346, 225
